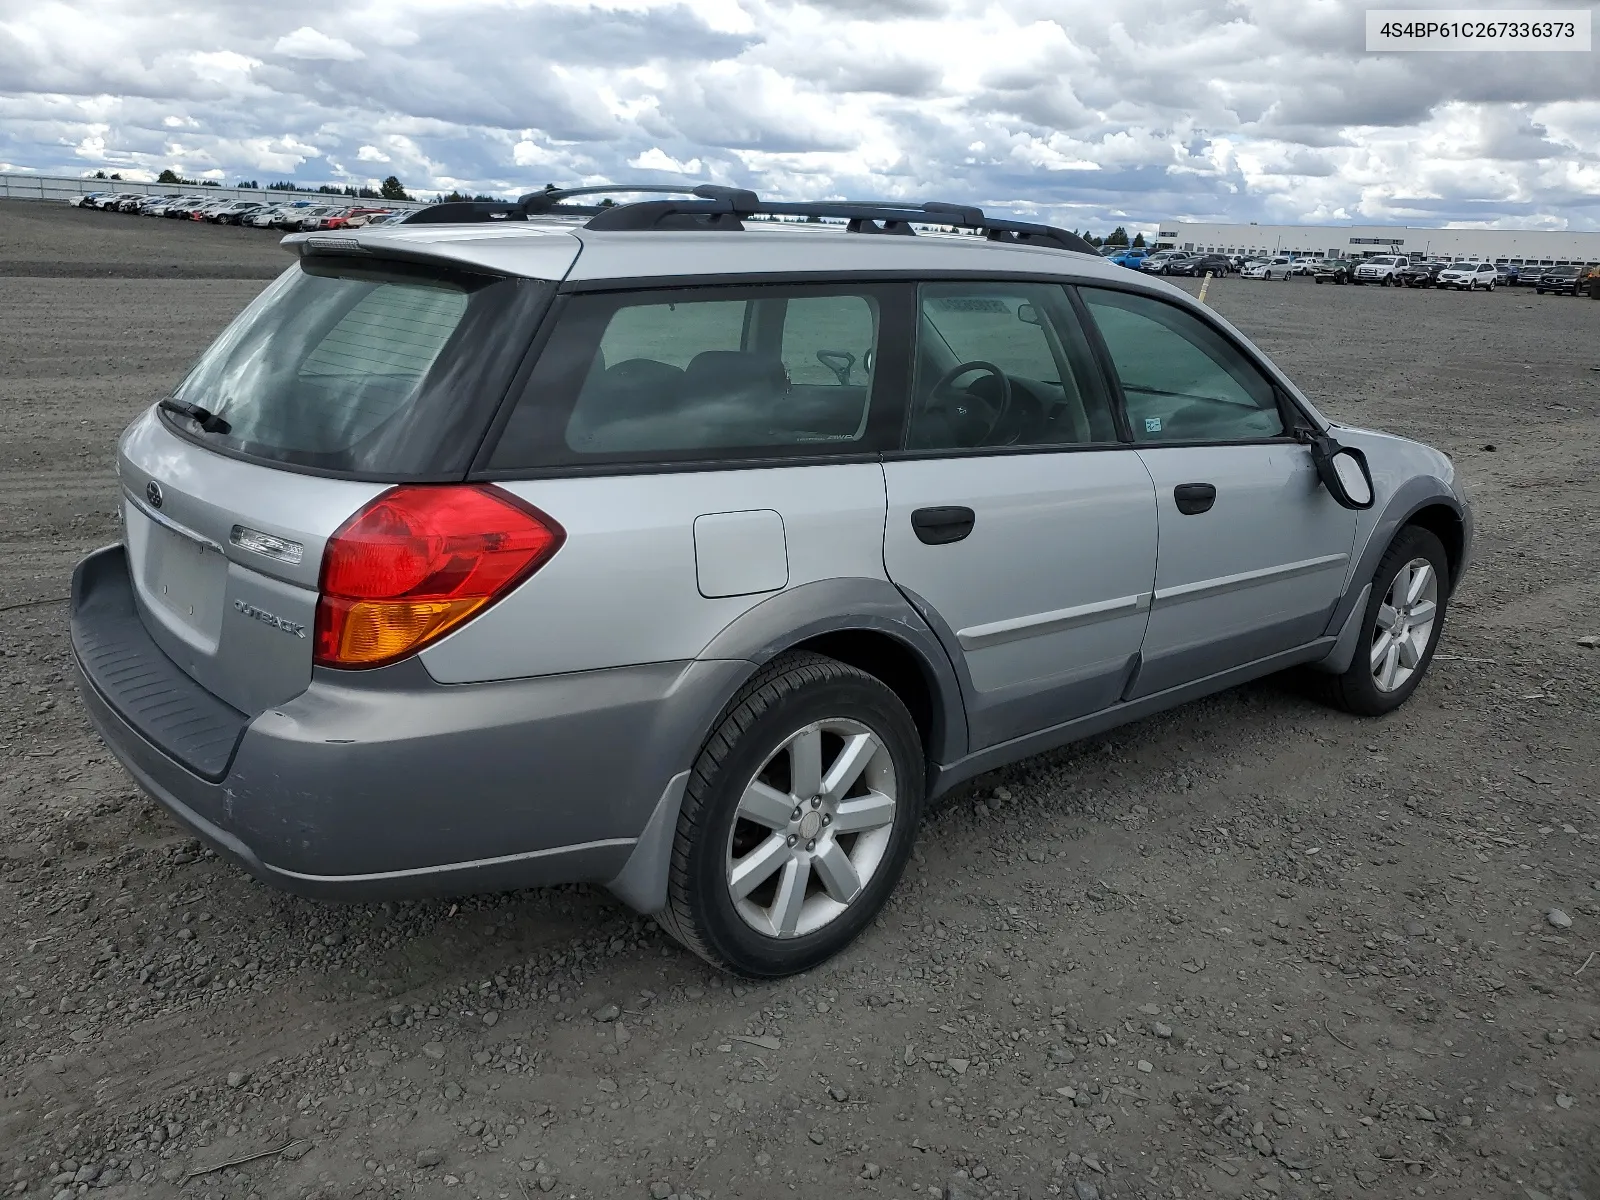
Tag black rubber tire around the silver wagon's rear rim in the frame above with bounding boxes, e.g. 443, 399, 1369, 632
658, 651, 926, 979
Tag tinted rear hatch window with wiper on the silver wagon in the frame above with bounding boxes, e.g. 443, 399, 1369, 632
162, 256, 554, 478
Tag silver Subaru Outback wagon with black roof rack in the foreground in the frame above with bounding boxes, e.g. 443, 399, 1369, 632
72, 187, 1472, 976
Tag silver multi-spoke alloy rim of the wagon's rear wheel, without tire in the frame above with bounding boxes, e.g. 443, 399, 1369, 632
726, 717, 899, 938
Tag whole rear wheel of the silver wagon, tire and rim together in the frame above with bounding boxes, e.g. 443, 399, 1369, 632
659, 653, 926, 979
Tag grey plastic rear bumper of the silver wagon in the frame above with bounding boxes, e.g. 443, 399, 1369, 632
72, 546, 750, 899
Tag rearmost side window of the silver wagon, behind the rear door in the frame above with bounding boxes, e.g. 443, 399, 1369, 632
488, 285, 898, 470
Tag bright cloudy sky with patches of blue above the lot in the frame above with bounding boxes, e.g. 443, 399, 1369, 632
0, 0, 1600, 232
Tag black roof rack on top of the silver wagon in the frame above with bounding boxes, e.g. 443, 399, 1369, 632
405, 184, 1096, 254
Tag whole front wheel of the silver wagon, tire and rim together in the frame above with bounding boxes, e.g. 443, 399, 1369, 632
1323, 525, 1450, 717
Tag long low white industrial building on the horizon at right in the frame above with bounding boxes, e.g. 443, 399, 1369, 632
1155, 221, 1600, 266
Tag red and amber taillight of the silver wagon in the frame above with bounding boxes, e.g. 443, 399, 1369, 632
314, 485, 566, 678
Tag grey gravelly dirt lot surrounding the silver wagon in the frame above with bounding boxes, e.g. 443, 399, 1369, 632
0, 205, 1600, 1200
